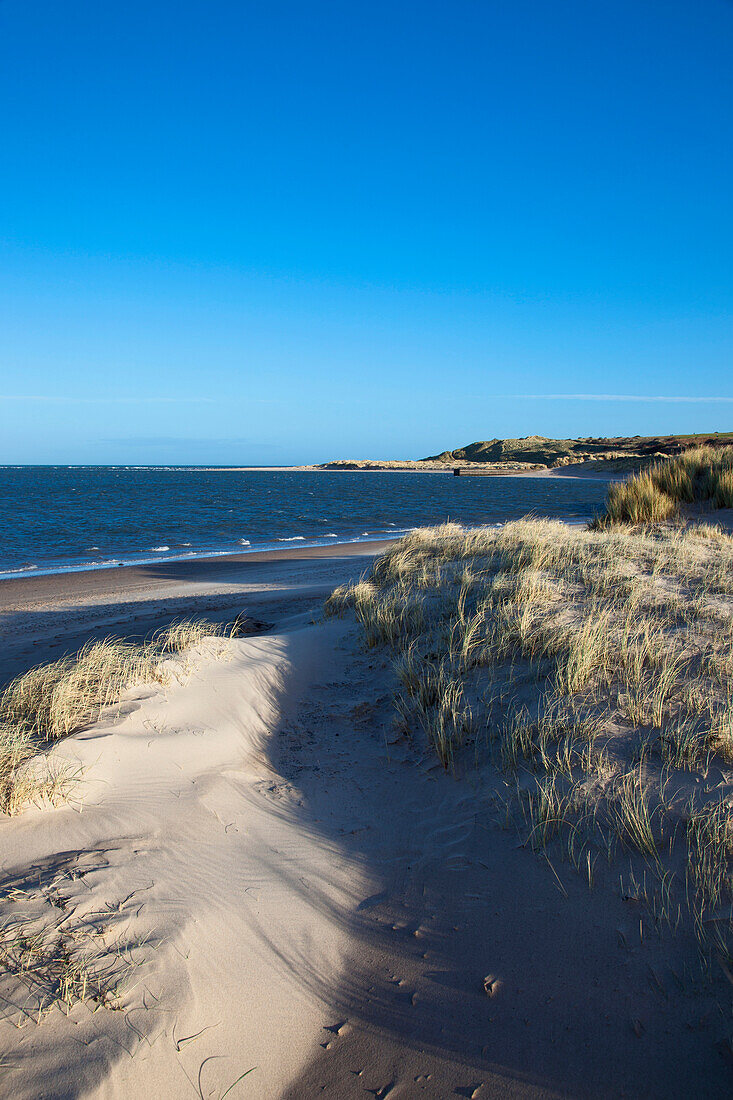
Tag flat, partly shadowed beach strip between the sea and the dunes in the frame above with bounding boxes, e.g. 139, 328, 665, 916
0, 540, 394, 684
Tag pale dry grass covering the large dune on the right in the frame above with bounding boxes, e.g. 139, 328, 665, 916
326, 519, 733, 976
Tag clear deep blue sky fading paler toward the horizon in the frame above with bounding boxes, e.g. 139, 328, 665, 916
0, 0, 733, 464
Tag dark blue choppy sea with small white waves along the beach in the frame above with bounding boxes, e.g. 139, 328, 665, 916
0, 466, 606, 578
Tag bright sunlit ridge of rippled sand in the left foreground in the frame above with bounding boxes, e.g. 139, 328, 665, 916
2, 631, 369, 1097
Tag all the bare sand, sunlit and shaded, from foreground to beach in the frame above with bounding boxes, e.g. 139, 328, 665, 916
0, 547, 731, 1100
